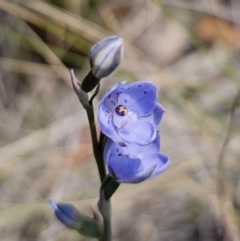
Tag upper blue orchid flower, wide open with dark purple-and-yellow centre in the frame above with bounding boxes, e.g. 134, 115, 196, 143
98, 81, 165, 146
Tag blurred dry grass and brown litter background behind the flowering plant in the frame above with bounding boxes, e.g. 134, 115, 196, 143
0, 0, 240, 241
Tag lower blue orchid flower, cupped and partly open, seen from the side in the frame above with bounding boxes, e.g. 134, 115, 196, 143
104, 132, 170, 183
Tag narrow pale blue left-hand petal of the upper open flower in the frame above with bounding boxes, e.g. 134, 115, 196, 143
98, 104, 123, 143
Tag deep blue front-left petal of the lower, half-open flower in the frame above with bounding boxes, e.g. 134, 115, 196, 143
108, 156, 143, 180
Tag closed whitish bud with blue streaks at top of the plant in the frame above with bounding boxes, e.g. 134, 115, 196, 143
89, 36, 123, 79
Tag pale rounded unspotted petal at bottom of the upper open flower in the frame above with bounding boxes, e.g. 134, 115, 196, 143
118, 120, 157, 145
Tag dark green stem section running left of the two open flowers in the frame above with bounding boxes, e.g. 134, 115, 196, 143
86, 105, 106, 182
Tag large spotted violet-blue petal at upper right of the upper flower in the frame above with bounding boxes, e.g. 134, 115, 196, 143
118, 81, 157, 117
